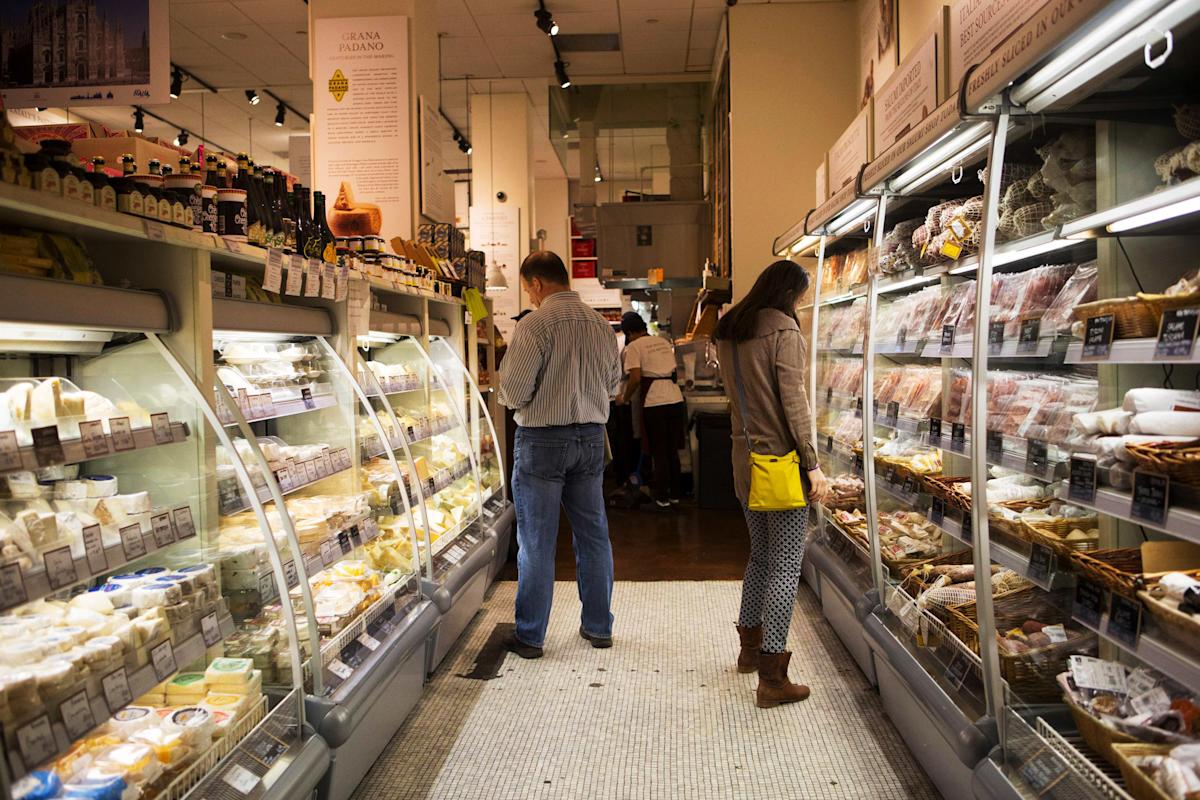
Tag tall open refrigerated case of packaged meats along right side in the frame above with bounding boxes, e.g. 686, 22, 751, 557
775, 1, 1200, 800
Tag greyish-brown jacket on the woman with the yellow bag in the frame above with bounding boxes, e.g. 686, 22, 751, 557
716, 308, 820, 504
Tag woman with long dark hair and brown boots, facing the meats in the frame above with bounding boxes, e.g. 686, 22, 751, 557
715, 261, 828, 709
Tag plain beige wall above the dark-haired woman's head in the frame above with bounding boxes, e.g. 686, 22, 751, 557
730, 2, 858, 297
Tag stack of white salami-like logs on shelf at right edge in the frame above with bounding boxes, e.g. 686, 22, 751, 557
1067, 386, 1200, 489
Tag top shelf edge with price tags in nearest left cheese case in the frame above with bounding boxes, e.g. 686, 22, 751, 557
0, 419, 188, 474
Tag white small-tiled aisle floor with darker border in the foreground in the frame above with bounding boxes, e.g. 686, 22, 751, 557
354, 581, 937, 800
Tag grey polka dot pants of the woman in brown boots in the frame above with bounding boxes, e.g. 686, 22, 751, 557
738, 506, 809, 652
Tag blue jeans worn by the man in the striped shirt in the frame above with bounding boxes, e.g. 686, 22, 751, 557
512, 425, 612, 648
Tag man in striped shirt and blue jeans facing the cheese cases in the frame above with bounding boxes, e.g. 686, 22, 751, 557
499, 251, 620, 658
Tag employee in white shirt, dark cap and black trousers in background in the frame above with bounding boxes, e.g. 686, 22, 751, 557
619, 311, 686, 509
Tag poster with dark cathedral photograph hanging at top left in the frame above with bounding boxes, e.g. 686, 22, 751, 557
0, 0, 170, 108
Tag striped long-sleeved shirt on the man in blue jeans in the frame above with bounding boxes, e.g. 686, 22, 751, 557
500, 291, 620, 428
